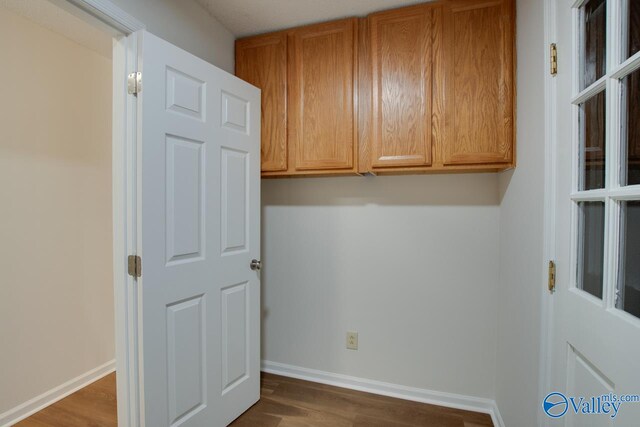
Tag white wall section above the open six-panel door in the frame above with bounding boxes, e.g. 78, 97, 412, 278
111, 0, 235, 73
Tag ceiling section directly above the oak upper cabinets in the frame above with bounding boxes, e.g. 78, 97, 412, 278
195, 0, 425, 37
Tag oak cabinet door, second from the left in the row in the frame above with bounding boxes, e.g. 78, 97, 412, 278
289, 19, 357, 170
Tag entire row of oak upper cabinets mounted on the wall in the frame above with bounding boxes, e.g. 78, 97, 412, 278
236, 0, 515, 177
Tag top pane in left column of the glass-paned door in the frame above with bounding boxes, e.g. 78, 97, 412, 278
580, 0, 607, 89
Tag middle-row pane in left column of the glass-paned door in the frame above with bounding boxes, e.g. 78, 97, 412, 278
578, 92, 606, 191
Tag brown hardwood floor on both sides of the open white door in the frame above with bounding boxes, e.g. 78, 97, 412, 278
16, 374, 493, 427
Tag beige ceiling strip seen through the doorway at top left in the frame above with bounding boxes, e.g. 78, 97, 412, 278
0, 0, 113, 58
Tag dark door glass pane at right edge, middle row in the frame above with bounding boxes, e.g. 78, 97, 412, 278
622, 68, 640, 185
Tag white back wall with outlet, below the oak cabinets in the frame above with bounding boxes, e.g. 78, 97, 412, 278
262, 174, 499, 398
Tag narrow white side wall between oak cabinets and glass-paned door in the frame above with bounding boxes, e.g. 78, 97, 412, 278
496, 0, 547, 426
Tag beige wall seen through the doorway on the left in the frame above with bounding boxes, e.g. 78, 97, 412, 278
0, 8, 115, 414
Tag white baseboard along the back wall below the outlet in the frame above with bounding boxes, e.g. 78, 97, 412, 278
262, 360, 504, 427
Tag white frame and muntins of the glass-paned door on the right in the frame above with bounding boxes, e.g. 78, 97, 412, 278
548, 0, 640, 426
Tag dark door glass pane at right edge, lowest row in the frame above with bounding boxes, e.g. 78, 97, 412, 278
616, 201, 640, 317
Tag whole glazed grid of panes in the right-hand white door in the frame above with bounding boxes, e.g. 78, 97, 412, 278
571, 0, 640, 318
